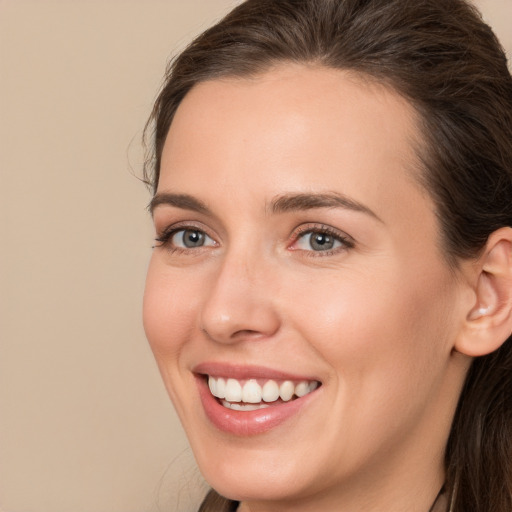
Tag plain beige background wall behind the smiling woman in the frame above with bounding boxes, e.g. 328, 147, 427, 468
0, 0, 512, 512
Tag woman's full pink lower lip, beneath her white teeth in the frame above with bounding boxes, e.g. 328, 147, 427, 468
196, 375, 316, 437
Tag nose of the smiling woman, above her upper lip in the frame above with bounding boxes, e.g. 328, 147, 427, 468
200, 251, 280, 343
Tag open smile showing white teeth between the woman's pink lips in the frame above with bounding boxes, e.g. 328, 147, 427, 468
206, 375, 320, 411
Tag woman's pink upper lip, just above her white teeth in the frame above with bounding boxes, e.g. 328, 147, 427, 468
192, 362, 319, 381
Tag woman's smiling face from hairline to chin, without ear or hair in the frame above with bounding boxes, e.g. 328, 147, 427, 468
144, 65, 463, 510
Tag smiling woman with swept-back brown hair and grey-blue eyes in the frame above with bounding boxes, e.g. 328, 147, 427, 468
144, 0, 512, 512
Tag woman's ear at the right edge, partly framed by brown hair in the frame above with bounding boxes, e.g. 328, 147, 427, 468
455, 227, 512, 357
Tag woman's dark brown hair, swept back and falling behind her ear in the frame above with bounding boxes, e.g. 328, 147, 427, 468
145, 0, 512, 512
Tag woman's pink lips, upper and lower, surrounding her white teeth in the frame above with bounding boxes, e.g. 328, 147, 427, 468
194, 363, 316, 436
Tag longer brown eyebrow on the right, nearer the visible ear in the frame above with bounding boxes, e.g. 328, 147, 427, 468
269, 192, 382, 222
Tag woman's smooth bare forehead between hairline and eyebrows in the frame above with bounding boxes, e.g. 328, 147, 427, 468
159, 64, 423, 224
